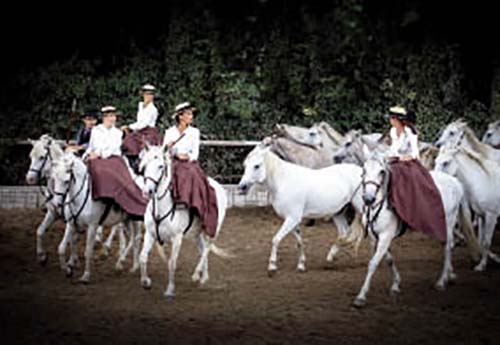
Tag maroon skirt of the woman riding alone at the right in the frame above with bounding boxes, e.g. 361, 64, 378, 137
389, 160, 447, 242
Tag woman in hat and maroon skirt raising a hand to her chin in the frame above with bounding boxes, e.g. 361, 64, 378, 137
164, 102, 218, 236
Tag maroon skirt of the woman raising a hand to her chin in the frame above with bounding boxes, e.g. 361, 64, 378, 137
172, 159, 218, 237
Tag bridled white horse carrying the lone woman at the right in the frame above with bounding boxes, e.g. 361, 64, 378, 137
353, 148, 480, 307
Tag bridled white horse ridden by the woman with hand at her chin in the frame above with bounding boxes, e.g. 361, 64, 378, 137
140, 145, 231, 299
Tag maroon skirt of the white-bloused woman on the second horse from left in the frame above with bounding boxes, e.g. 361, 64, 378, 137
88, 156, 148, 217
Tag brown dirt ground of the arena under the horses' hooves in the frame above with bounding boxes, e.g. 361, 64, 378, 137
0, 208, 500, 345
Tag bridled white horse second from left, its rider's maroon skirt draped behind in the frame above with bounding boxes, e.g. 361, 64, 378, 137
51, 152, 141, 283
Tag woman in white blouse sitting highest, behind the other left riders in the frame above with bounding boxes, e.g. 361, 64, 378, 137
121, 84, 163, 171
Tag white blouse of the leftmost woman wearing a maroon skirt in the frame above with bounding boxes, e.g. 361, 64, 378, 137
84, 124, 123, 158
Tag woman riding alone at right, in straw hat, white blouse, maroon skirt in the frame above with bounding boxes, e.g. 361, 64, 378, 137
388, 106, 446, 242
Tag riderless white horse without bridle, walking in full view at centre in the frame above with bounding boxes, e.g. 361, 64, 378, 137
238, 143, 362, 275
